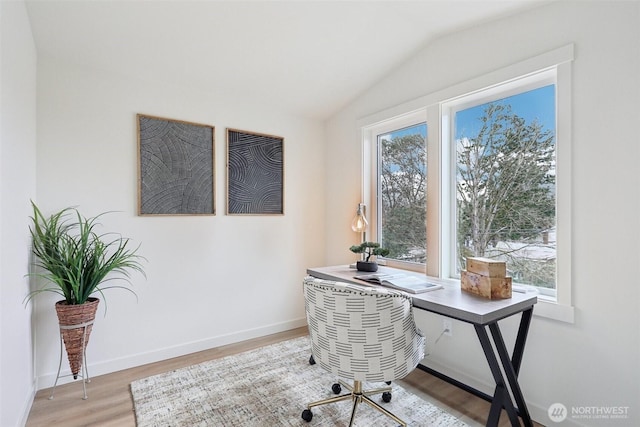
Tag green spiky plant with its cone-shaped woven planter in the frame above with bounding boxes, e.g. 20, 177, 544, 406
26, 202, 144, 379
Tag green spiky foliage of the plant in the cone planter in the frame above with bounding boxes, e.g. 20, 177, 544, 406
26, 202, 144, 310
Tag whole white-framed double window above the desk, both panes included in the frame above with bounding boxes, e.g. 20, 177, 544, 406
359, 45, 574, 322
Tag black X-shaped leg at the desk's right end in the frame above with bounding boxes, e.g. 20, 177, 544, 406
475, 308, 533, 427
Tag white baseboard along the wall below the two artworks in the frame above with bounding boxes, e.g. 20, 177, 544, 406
36, 318, 307, 390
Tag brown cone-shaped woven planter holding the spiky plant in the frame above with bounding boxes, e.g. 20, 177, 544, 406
56, 298, 100, 379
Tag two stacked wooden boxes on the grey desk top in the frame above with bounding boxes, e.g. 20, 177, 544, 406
460, 258, 512, 299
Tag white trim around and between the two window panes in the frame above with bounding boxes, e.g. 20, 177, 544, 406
357, 44, 575, 323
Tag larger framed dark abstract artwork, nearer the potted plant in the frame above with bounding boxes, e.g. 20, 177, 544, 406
137, 114, 215, 215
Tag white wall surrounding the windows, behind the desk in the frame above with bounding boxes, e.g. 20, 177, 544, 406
326, 2, 640, 426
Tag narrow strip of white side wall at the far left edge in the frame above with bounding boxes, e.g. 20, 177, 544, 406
0, 1, 36, 426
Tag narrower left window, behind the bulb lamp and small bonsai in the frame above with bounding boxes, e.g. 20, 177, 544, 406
363, 108, 428, 271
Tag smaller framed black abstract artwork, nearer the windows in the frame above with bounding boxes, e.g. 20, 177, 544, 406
227, 129, 284, 215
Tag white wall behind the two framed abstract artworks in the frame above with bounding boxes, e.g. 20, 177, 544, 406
31, 51, 325, 386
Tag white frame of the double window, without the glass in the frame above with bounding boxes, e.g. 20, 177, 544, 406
357, 44, 575, 323
